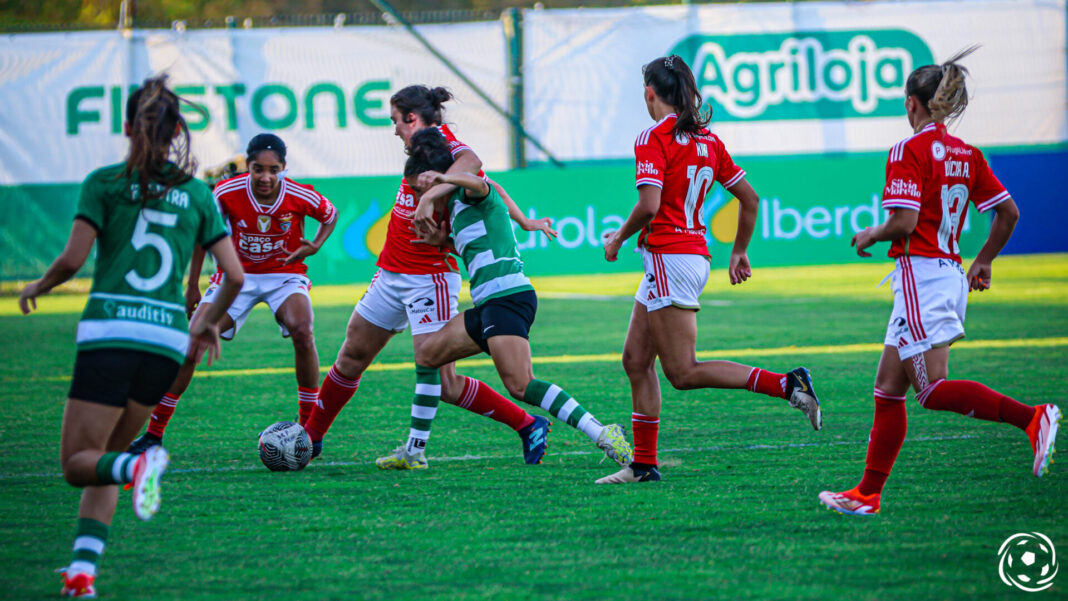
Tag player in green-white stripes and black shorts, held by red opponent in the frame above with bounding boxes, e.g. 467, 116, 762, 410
379, 129, 631, 465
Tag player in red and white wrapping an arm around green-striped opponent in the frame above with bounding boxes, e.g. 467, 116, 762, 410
307, 85, 555, 470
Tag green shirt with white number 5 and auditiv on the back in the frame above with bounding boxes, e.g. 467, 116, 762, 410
76, 163, 226, 363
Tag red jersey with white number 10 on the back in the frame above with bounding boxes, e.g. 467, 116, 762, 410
634, 113, 745, 256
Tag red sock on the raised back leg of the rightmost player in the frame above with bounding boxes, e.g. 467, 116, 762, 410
916, 380, 1035, 430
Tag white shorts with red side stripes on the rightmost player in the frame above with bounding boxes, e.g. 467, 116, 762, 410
885, 256, 968, 361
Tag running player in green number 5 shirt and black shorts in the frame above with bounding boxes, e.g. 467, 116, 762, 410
19, 77, 241, 598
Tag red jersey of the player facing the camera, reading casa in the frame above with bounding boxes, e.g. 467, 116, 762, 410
215, 173, 337, 273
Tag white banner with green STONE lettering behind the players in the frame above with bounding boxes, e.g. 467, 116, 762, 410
0, 22, 509, 185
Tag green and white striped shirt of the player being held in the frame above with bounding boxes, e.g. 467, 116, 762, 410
449, 186, 534, 304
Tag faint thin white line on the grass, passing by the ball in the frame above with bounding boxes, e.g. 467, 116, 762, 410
0, 434, 979, 481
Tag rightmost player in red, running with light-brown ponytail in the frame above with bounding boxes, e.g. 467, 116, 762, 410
819, 47, 1061, 516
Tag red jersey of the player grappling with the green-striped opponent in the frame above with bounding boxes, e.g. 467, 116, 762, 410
377, 124, 485, 275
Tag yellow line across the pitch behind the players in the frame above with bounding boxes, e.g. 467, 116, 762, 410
18, 336, 1068, 382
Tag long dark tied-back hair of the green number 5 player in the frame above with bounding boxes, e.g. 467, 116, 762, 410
122, 75, 197, 204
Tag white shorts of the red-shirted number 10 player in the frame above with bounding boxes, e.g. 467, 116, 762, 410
634, 249, 709, 311
